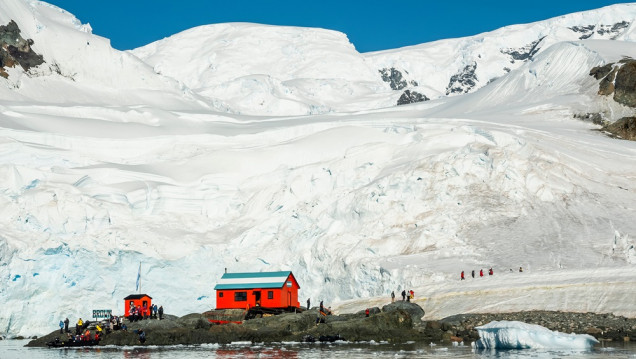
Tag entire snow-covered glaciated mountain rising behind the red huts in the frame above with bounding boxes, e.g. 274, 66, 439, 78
0, 0, 636, 335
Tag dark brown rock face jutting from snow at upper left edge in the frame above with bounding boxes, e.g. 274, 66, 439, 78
0, 20, 44, 78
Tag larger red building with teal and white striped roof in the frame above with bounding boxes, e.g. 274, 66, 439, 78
214, 271, 300, 309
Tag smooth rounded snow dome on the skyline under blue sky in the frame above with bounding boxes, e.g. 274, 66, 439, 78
132, 23, 390, 115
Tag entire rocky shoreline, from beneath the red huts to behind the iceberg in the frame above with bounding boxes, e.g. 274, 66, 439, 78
27, 302, 636, 347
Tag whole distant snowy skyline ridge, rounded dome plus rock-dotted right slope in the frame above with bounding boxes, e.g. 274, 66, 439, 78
131, 4, 636, 116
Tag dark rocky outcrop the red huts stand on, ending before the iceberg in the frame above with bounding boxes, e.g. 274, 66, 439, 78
28, 303, 434, 347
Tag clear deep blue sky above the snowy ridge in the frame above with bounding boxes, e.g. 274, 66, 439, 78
47, 0, 630, 52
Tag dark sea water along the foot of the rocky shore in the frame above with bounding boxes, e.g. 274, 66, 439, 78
0, 340, 636, 359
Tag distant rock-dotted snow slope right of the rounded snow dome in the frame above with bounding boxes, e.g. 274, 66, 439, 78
364, 3, 636, 98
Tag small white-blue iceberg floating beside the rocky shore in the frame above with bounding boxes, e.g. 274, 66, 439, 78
472, 321, 598, 350
